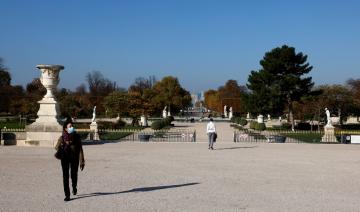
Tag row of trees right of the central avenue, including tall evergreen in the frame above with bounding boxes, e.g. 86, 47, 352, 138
205, 45, 360, 125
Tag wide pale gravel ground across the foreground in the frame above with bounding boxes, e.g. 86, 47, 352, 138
0, 141, 360, 211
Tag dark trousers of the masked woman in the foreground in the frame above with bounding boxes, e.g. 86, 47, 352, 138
61, 158, 79, 197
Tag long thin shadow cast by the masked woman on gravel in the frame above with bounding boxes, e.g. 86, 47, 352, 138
71, 183, 200, 200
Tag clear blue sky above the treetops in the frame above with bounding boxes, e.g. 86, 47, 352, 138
0, 0, 360, 92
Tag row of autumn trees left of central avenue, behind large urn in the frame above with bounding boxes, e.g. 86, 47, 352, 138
0, 60, 191, 121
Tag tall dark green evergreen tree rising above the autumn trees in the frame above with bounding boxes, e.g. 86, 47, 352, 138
247, 45, 314, 128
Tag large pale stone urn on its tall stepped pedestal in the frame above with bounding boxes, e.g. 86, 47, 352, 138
25, 65, 64, 147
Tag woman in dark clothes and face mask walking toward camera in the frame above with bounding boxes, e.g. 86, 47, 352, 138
55, 119, 85, 201
